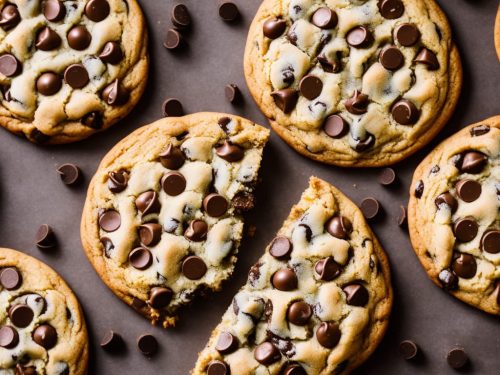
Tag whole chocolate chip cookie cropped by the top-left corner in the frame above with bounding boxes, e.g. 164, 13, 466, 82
0, 0, 148, 144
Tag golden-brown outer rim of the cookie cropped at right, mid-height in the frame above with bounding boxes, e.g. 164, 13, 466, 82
408, 116, 500, 316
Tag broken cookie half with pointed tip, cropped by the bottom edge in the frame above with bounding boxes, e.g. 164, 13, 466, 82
193, 177, 392, 375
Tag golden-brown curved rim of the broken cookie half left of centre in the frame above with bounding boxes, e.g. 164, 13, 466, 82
80, 112, 270, 328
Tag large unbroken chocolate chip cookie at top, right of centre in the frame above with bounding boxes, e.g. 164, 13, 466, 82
245, 0, 462, 167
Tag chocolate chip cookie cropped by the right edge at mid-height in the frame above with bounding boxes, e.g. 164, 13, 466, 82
408, 116, 500, 315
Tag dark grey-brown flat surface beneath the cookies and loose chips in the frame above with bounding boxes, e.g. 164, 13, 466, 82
0, 0, 500, 375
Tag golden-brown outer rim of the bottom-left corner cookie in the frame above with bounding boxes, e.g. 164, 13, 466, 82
0, 247, 89, 375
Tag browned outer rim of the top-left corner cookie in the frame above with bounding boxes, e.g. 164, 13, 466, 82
0, 0, 149, 145
